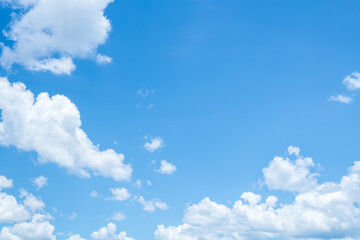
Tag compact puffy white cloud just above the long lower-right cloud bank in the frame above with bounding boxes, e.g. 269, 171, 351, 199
263, 154, 318, 192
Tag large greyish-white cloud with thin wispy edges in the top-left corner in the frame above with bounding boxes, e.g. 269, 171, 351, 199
0, 0, 113, 74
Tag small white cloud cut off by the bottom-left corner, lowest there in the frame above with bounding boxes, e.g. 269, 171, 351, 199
0, 214, 56, 240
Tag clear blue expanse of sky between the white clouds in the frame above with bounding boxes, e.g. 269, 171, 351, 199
0, 0, 360, 240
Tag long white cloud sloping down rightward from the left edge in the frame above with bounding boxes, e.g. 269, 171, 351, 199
0, 78, 132, 181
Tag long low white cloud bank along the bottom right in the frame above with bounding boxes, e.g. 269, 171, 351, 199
155, 149, 360, 240
